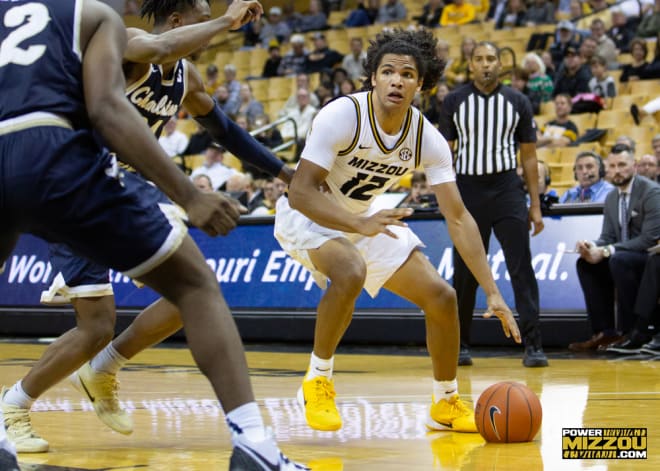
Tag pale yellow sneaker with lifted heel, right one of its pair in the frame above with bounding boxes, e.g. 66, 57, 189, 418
69, 362, 133, 435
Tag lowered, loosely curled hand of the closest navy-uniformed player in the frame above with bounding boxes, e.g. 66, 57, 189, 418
185, 191, 240, 236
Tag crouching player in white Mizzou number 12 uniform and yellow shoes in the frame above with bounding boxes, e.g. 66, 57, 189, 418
275, 30, 520, 432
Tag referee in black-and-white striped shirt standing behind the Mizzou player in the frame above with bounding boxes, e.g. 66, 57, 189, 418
439, 41, 548, 367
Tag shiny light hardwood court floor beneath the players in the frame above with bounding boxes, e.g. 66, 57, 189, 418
0, 342, 660, 471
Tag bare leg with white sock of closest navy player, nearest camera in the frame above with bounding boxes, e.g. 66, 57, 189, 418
139, 236, 306, 469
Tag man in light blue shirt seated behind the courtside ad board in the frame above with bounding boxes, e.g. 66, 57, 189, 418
559, 151, 614, 203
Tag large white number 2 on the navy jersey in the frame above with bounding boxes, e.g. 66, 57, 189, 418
0, 3, 50, 67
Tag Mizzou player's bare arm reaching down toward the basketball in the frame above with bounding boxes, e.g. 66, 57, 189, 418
431, 182, 521, 343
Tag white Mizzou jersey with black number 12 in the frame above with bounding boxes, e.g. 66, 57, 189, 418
303, 92, 424, 213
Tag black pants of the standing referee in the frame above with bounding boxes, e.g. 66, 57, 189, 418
454, 170, 541, 347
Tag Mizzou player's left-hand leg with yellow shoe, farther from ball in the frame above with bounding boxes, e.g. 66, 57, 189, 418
298, 237, 366, 431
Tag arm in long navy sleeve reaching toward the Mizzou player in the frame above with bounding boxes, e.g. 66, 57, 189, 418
183, 65, 293, 183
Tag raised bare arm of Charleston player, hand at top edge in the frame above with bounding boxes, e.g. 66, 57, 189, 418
124, 0, 263, 64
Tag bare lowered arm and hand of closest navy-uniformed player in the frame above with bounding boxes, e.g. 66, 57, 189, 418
81, 0, 239, 235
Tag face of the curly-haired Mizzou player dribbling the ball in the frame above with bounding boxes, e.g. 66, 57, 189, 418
371, 54, 422, 109
